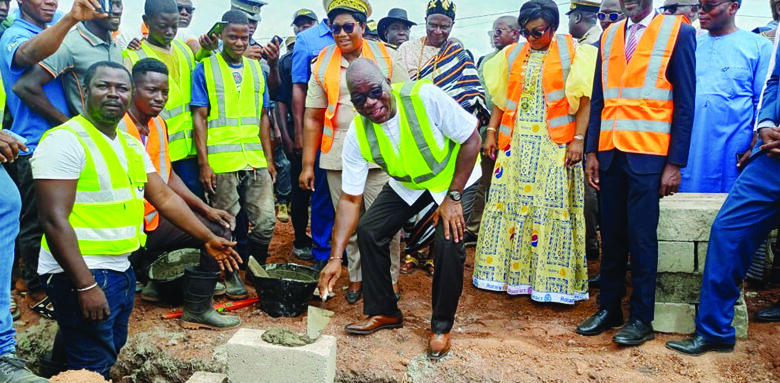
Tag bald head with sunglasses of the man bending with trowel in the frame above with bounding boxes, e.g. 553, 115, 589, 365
347, 58, 396, 124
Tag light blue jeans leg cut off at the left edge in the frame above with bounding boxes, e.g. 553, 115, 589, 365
0, 166, 22, 355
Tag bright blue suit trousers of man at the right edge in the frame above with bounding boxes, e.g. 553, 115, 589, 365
696, 152, 780, 344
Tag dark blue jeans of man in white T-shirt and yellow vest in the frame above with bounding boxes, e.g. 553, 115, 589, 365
41, 268, 135, 379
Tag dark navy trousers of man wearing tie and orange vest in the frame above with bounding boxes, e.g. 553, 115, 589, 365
599, 151, 661, 325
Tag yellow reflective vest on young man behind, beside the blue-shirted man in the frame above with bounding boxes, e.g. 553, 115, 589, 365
124, 39, 197, 161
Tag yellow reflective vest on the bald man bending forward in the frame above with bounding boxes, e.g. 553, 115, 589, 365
354, 80, 460, 192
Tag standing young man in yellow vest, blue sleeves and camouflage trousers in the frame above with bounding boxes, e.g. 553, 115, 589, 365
191, 10, 276, 263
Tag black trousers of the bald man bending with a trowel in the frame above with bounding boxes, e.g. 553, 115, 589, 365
356, 184, 478, 333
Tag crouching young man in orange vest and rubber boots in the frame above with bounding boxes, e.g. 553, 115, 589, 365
124, 58, 249, 329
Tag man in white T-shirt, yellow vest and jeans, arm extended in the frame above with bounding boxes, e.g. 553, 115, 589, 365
32, 62, 240, 378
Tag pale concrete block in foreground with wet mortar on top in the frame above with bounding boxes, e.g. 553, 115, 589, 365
225, 329, 336, 383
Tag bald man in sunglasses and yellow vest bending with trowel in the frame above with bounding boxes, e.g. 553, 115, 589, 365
319, 59, 481, 360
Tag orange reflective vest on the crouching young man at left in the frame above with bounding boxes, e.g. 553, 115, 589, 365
118, 113, 171, 231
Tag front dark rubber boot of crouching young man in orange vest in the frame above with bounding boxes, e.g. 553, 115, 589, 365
179, 267, 241, 330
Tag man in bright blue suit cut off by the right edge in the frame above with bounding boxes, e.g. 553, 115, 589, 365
666, 12, 780, 355
